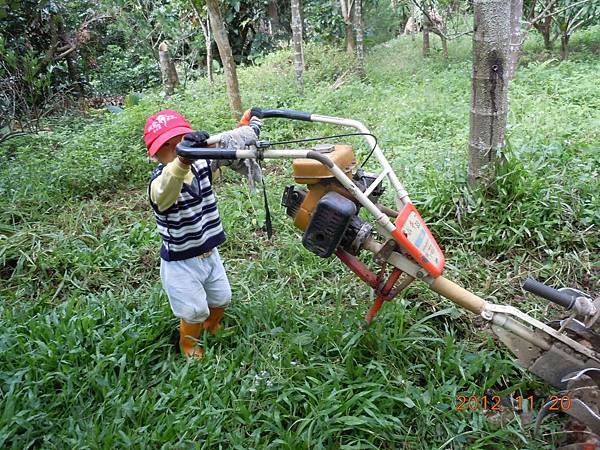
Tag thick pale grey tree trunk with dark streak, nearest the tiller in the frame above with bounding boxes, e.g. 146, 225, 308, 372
468, 0, 510, 186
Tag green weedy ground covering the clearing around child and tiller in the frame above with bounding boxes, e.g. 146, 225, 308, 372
0, 27, 600, 449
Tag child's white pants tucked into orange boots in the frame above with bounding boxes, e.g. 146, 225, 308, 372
160, 248, 231, 323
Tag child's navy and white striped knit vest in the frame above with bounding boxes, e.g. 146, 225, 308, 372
148, 159, 225, 261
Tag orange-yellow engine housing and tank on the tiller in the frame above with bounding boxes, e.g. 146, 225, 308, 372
292, 144, 356, 230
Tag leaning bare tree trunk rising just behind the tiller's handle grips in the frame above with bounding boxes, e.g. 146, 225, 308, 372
206, 0, 242, 119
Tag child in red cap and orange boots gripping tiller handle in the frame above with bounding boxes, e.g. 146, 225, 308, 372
144, 109, 260, 358
